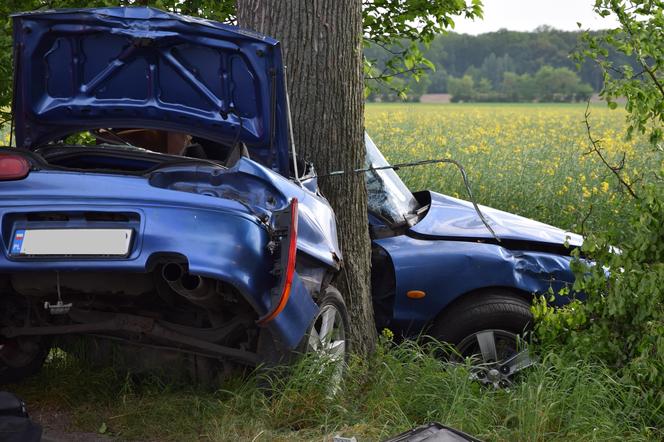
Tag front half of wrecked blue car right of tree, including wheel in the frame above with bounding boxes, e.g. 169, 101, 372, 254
365, 135, 583, 387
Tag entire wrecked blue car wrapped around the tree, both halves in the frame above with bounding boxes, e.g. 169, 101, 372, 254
0, 7, 581, 385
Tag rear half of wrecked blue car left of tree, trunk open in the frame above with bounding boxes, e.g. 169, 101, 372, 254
0, 7, 348, 383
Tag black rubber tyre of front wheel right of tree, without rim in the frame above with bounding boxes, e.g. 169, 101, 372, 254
430, 289, 533, 357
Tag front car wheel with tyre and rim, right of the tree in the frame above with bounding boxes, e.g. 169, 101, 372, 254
431, 290, 533, 388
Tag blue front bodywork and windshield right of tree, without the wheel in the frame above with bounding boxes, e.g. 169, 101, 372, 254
365, 135, 582, 336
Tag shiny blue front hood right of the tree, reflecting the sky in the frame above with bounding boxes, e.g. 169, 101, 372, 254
411, 192, 583, 247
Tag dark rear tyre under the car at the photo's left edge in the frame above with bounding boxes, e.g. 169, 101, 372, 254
0, 337, 51, 385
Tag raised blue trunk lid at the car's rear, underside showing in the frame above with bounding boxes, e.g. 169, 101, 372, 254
13, 7, 288, 174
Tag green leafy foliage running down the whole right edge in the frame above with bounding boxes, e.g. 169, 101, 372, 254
534, 0, 664, 428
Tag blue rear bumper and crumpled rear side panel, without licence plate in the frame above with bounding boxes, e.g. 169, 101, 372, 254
0, 158, 341, 346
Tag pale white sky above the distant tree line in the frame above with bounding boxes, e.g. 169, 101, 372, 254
453, 0, 616, 35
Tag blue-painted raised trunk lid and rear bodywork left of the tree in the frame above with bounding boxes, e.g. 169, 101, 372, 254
6, 7, 342, 347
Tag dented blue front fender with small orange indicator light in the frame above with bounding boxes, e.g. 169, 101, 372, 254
374, 235, 574, 333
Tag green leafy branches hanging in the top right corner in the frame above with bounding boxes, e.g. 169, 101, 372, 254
575, 0, 664, 144
